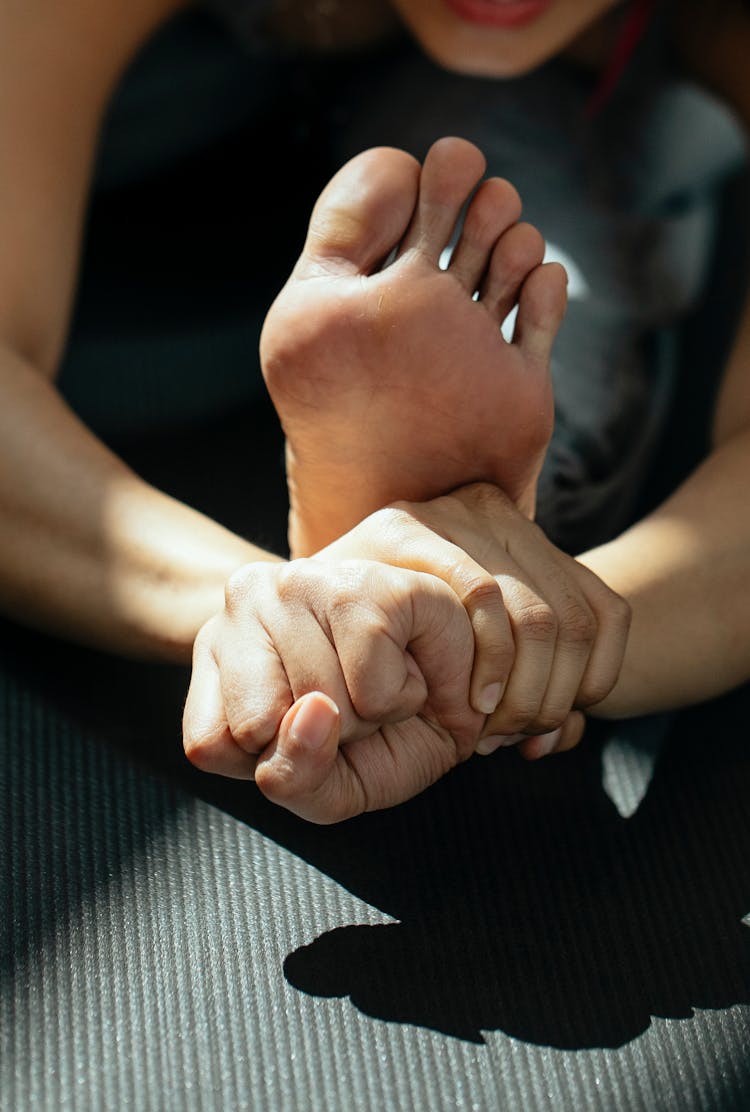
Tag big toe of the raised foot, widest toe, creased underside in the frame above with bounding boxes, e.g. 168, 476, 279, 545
296, 147, 420, 277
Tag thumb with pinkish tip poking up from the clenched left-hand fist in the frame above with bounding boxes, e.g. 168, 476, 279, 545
255, 692, 341, 822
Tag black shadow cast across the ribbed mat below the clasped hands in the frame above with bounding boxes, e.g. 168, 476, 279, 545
4, 600, 750, 1050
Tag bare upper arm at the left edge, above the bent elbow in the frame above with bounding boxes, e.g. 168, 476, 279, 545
0, 0, 190, 375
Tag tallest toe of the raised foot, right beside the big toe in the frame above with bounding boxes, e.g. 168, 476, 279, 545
401, 138, 486, 265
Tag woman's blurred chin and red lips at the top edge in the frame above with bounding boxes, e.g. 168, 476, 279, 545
393, 0, 619, 78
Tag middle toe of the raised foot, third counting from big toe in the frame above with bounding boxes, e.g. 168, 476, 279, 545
451, 178, 521, 294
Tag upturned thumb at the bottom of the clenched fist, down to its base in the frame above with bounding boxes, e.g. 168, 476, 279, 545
255, 692, 367, 823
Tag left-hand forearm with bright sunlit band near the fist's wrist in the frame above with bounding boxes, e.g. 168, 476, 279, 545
0, 348, 276, 662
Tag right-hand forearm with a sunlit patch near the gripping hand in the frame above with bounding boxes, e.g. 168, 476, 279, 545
580, 430, 750, 717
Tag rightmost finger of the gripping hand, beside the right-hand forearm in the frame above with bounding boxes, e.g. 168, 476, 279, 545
573, 560, 630, 707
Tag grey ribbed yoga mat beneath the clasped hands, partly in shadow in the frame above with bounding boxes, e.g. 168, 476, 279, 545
0, 631, 750, 1112
